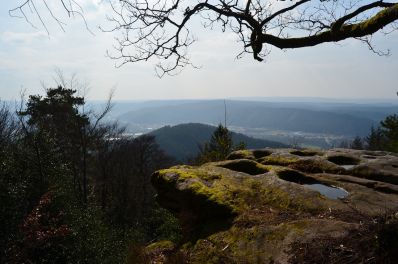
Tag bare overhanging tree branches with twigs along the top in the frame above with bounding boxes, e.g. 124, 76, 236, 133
10, 0, 398, 75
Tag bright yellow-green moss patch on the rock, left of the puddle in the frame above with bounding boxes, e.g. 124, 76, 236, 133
159, 165, 317, 219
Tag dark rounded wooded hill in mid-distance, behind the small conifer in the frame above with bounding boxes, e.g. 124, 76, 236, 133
149, 123, 287, 161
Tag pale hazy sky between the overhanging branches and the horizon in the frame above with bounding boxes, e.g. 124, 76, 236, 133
0, 0, 398, 100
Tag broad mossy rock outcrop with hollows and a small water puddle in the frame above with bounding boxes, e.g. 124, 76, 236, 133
152, 149, 398, 263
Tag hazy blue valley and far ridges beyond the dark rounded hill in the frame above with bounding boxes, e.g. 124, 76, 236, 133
103, 98, 398, 153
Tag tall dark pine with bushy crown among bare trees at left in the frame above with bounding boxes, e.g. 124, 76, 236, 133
18, 86, 90, 202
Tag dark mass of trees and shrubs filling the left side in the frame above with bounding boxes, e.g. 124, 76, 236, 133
0, 86, 179, 263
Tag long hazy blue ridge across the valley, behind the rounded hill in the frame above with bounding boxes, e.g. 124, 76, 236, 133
118, 100, 386, 136
